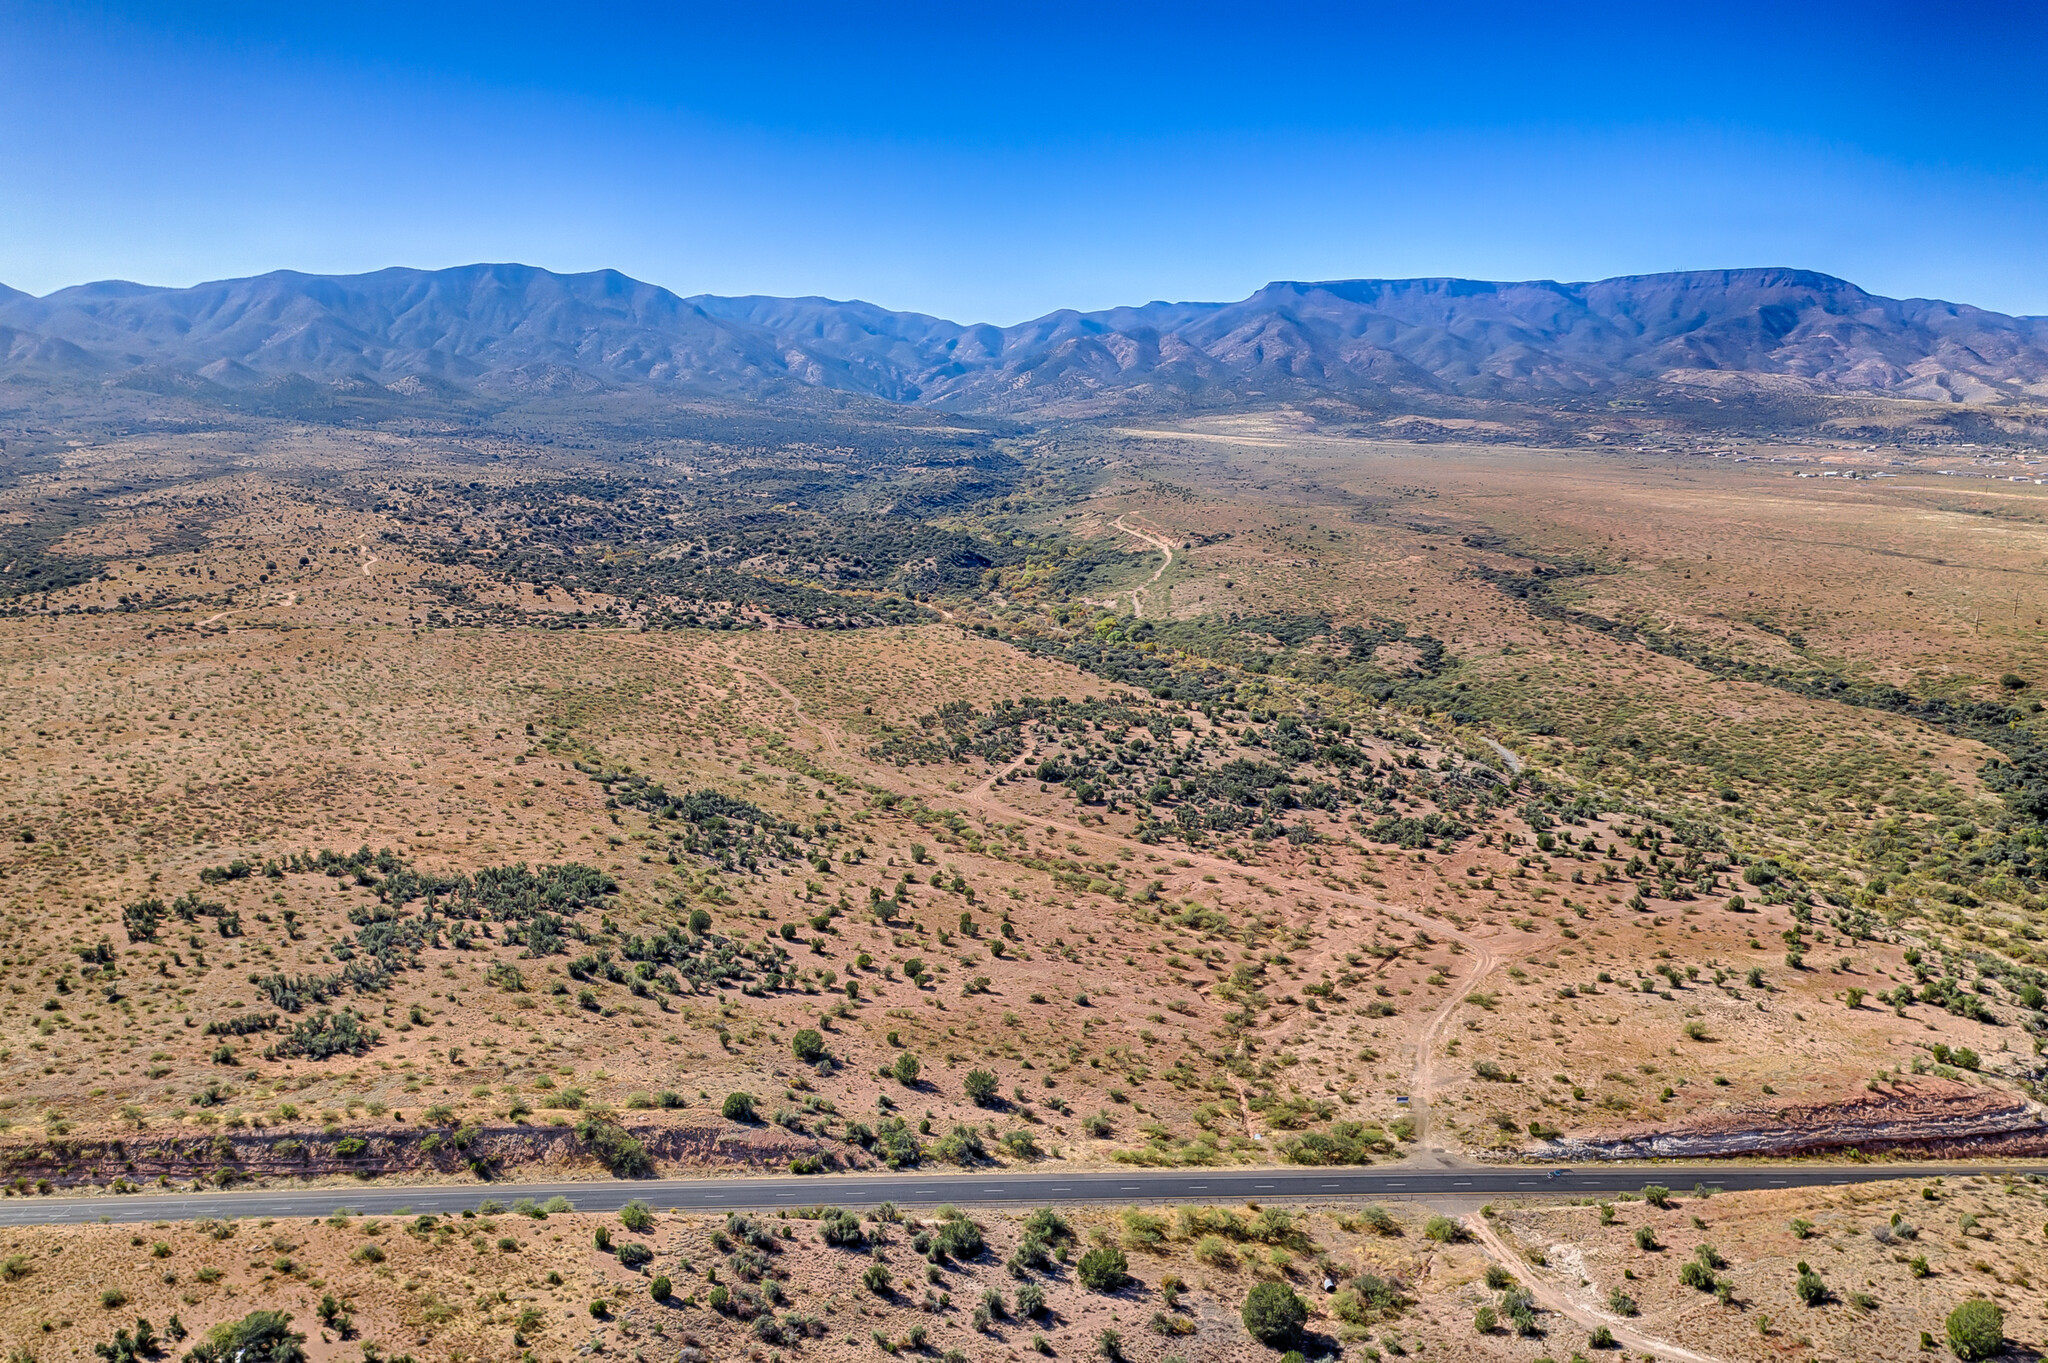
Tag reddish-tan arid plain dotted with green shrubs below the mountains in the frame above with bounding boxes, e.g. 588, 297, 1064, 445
0, 417, 2048, 1359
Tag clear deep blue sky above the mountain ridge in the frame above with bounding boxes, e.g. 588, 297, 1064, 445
0, 0, 2048, 323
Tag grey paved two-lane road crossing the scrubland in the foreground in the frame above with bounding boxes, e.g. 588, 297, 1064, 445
0, 1164, 2040, 1226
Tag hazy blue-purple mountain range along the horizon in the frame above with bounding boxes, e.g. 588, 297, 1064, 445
0, 264, 2048, 413
